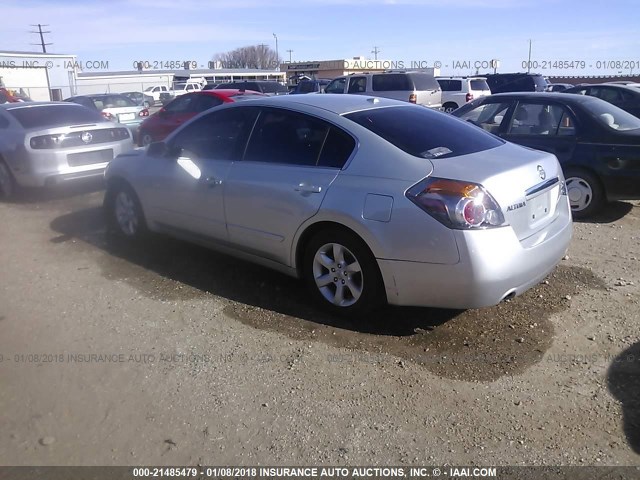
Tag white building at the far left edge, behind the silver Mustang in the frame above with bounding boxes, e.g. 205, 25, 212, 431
0, 51, 78, 101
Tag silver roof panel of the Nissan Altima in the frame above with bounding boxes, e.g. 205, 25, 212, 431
232, 94, 412, 115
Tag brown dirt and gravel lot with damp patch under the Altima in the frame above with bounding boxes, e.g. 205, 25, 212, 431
0, 179, 640, 465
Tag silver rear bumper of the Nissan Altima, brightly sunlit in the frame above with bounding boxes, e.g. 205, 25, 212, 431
378, 204, 572, 309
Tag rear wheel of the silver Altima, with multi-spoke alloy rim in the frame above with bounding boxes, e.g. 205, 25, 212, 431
303, 228, 386, 317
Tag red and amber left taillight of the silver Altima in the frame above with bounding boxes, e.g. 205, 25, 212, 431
406, 178, 506, 230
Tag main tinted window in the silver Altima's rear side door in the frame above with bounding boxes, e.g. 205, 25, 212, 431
244, 108, 329, 166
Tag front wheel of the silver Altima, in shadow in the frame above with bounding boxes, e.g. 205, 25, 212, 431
104, 181, 148, 241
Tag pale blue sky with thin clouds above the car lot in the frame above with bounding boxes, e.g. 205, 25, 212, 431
0, 0, 640, 76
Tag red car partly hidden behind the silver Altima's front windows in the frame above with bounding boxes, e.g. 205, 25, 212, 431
138, 89, 264, 147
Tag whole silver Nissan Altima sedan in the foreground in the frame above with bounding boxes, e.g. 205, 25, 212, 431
104, 95, 572, 315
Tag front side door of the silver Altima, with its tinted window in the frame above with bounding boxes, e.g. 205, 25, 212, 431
146, 108, 258, 241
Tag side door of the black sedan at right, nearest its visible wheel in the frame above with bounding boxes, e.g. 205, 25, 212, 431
500, 100, 578, 163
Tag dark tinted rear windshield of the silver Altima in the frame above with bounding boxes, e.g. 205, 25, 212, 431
345, 106, 504, 158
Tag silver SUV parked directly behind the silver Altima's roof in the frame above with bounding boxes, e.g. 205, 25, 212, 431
324, 72, 442, 109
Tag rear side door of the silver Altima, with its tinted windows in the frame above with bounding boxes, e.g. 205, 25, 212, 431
225, 108, 355, 265
